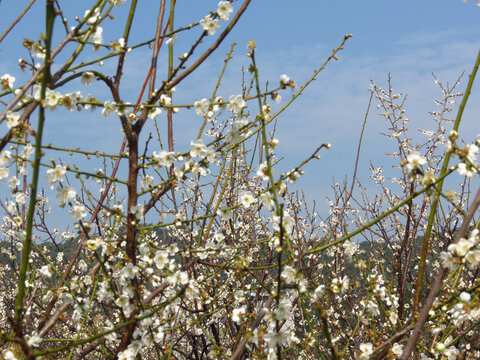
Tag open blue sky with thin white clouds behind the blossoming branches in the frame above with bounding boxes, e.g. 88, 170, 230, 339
0, 0, 480, 222
